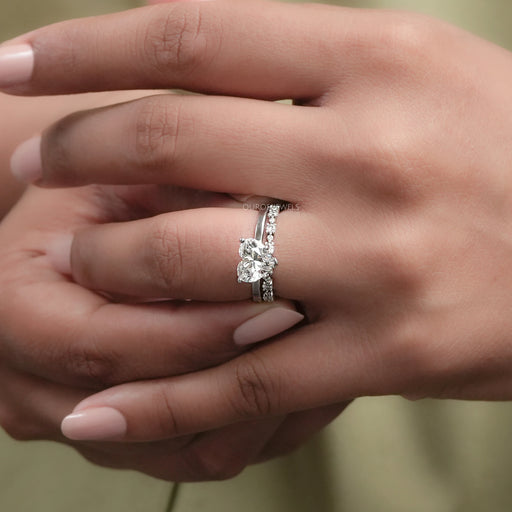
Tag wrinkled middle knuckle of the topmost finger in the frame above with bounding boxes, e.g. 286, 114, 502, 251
144, 4, 206, 77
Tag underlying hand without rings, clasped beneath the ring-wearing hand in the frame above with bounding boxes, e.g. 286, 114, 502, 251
0, 179, 344, 481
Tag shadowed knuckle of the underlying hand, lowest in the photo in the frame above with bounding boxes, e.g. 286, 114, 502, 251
186, 447, 245, 481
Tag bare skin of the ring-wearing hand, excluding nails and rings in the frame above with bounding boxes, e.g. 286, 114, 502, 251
5, 1, 512, 480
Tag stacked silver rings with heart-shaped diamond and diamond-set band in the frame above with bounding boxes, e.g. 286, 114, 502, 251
236, 204, 281, 302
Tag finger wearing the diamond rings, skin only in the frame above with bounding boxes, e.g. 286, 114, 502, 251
66, 208, 310, 301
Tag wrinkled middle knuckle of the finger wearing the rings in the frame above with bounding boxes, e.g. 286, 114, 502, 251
146, 218, 184, 294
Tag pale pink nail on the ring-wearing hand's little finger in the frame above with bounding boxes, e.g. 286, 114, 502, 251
61, 407, 128, 441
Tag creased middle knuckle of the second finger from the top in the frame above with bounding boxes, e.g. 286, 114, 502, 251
133, 97, 189, 172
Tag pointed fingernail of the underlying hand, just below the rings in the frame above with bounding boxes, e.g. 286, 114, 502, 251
233, 307, 304, 345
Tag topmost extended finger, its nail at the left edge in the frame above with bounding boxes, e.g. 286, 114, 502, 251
0, 1, 346, 99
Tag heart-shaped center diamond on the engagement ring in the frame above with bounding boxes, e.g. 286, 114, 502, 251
236, 238, 277, 283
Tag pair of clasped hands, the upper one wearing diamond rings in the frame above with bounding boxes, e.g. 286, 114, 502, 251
0, 0, 512, 480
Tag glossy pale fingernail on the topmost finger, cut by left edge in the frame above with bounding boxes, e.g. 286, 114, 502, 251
0, 44, 34, 88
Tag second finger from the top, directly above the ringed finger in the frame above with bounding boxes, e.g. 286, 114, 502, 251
12, 95, 321, 202
